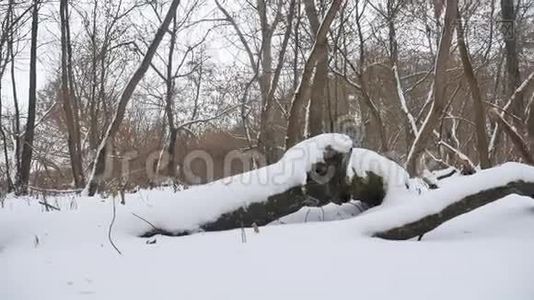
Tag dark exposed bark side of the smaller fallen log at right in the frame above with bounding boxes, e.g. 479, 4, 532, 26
374, 181, 534, 240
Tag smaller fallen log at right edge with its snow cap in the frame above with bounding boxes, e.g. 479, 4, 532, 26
348, 163, 534, 240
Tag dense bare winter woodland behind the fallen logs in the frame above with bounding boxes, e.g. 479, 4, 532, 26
0, 0, 534, 194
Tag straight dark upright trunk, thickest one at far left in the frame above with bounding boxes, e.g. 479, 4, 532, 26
16, 0, 40, 194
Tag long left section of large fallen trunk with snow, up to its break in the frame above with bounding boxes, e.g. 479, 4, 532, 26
133, 134, 352, 236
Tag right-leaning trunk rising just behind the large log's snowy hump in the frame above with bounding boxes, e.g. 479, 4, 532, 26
286, 0, 343, 148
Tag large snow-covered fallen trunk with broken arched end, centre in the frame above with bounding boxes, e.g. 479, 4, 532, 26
136, 142, 422, 237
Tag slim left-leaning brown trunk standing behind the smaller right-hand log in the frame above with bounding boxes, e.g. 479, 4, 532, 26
456, 10, 491, 169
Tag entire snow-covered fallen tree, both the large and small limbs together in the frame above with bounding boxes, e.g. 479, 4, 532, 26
136, 134, 534, 240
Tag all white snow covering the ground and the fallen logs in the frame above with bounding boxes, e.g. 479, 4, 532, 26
0, 135, 534, 300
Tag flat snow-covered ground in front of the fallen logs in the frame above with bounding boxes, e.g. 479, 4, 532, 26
0, 190, 534, 300
